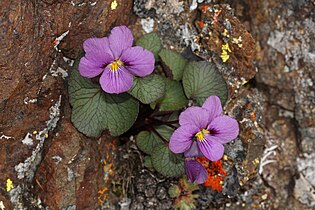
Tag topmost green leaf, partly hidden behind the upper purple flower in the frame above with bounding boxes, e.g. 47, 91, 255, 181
136, 33, 162, 60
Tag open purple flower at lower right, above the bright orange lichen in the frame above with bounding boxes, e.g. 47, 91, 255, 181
169, 96, 239, 161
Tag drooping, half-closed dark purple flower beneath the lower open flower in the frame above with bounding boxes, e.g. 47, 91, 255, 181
184, 141, 208, 184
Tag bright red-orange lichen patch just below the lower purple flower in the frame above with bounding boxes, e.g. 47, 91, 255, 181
196, 157, 226, 192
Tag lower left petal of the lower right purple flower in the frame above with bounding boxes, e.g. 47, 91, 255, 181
169, 125, 198, 153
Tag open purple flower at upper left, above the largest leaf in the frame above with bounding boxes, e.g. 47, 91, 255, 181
79, 26, 155, 93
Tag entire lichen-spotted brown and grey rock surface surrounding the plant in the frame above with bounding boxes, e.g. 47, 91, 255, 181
0, 0, 315, 209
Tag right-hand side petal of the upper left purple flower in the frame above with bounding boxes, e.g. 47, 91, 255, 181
120, 46, 155, 77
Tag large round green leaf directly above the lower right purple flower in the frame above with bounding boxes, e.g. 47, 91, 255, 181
183, 61, 228, 106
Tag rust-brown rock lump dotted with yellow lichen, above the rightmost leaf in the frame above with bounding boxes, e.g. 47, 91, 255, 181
195, 4, 256, 98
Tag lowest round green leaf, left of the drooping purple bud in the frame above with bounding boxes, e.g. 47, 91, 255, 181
151, 144, 184, 177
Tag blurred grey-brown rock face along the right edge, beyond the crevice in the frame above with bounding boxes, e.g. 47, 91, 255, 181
230, 0, 315, 209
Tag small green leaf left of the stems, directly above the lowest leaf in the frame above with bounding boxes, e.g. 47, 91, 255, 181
136, 131, 163, 155
